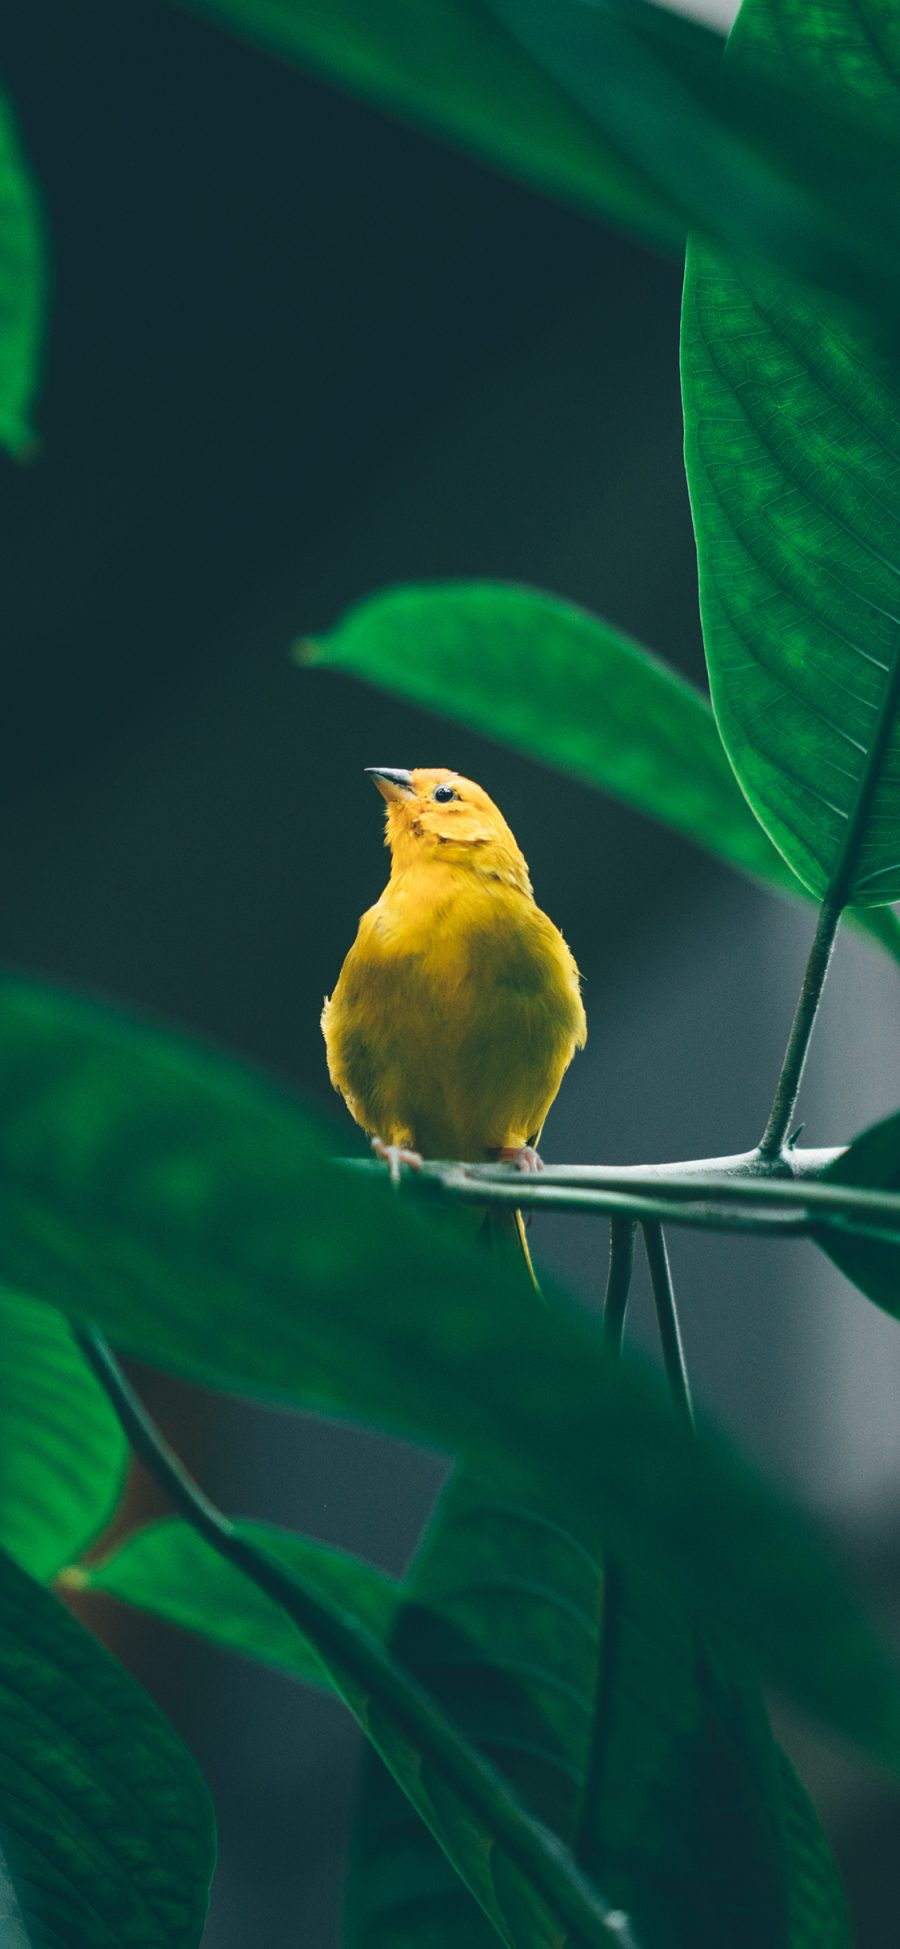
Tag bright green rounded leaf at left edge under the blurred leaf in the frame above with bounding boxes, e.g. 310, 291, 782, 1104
0, 1290, 129, 1579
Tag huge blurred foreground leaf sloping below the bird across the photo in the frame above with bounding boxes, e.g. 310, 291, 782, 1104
0, 980, 900, 1764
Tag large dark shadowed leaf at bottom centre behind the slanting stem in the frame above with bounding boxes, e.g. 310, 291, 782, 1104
349, 1475, 789, 1949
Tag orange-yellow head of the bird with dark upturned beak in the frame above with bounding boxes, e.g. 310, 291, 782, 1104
368, 766, 532, 893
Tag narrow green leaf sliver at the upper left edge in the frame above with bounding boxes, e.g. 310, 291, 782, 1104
0, 96, 47, 454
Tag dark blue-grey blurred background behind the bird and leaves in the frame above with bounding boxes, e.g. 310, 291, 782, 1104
0, 0, 900, 1949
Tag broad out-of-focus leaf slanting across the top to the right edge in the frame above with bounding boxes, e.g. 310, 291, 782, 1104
187, 0, 900, 310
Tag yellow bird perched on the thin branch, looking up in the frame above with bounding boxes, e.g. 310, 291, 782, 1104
321, 766, 586, 1263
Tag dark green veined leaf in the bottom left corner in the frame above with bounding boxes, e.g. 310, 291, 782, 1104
0, 1553, 214, 1949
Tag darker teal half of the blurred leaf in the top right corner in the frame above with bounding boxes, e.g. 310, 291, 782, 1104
487, 0, 900, 310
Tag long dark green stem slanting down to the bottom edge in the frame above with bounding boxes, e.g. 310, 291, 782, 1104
72, 1327, 637, 1949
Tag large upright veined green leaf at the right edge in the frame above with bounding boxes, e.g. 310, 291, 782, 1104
682, 0, 900, 906
